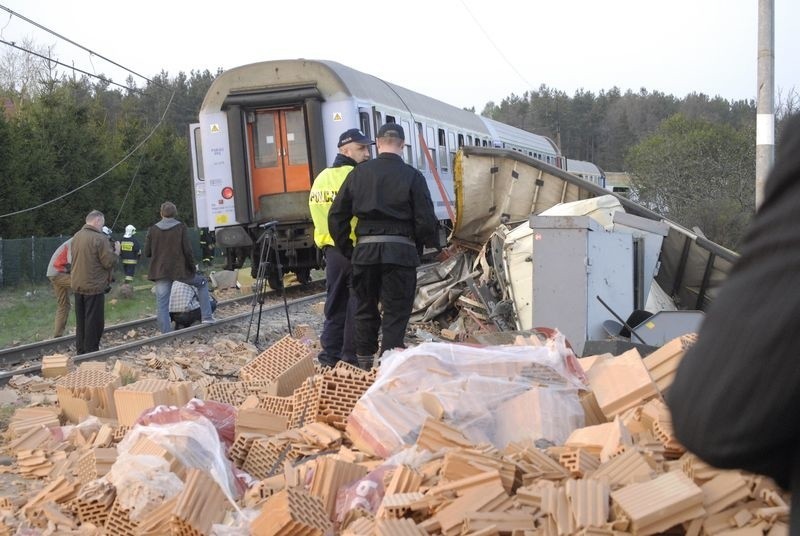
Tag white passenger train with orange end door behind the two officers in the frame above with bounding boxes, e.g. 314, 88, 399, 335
191, 59, 592, 287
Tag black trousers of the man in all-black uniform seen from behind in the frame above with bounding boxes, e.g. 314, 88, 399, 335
353, 264, 417, 356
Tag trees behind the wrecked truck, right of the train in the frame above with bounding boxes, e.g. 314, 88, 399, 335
482, 85, 800, 249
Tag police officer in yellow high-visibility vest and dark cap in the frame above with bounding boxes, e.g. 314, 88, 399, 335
308, 128, 375, 367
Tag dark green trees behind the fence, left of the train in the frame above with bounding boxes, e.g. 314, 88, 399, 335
0, 43, 215, 238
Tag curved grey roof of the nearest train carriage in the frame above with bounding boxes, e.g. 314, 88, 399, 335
201, 59, 489, 135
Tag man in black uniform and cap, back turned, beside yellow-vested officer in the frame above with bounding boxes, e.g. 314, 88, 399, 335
328, 123, 437, 369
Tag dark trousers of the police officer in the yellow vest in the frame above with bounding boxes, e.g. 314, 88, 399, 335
319, 247, 356, 366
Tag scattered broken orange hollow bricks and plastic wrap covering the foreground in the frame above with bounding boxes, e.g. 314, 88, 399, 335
0, 316, 789, 536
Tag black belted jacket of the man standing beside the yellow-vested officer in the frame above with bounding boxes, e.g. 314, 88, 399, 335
328, 153, 438, 266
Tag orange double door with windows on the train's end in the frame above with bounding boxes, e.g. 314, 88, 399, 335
247, 108, 311, 214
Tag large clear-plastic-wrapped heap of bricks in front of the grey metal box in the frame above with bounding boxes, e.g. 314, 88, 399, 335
347, 334, 586, 458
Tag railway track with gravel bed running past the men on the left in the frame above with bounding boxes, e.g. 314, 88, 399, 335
0, 280, 325, 385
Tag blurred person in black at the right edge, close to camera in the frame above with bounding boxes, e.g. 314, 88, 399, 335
668, 117, 800, 536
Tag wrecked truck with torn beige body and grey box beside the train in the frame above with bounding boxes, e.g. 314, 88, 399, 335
412, 147, 738, 356
